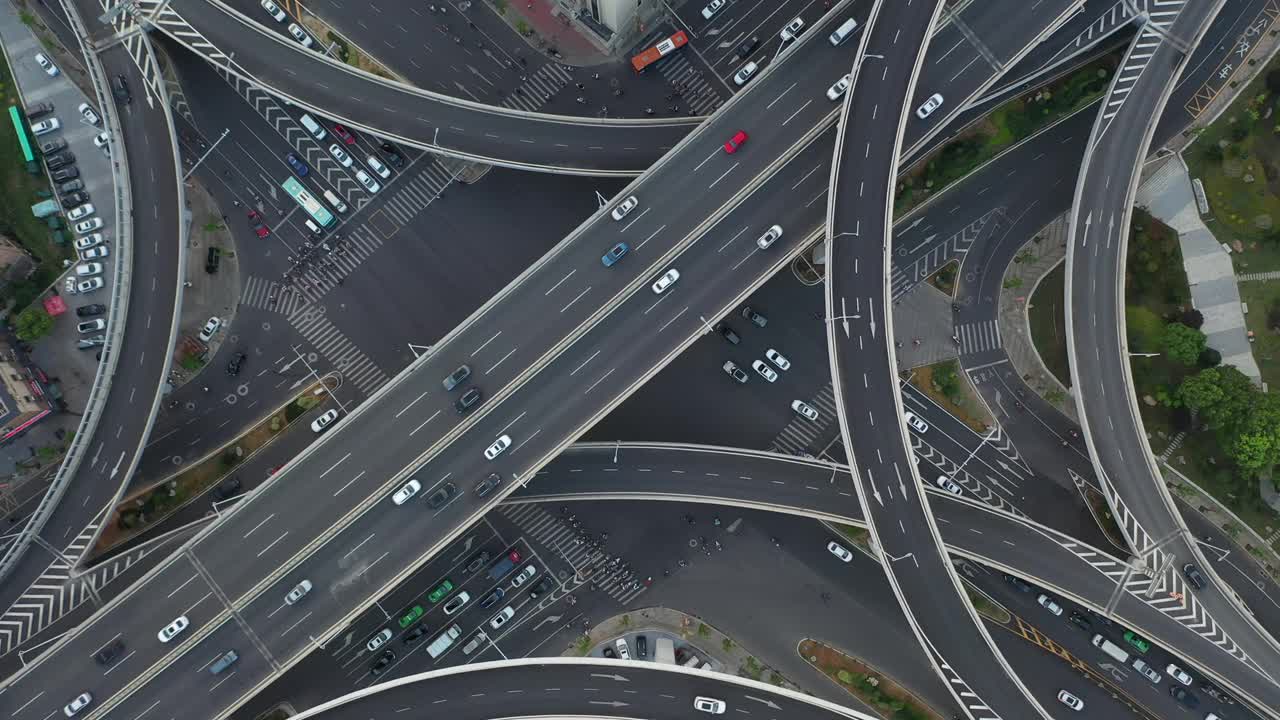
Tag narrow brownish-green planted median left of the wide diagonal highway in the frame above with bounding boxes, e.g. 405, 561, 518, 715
92, 378, 337, 556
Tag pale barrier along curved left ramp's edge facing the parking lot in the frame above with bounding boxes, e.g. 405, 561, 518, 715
0, 0, 133, 582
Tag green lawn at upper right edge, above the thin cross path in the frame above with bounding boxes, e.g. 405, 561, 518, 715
1183, 59, 1280, 272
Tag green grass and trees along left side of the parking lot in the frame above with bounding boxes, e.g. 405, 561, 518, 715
0, 49, 72, 307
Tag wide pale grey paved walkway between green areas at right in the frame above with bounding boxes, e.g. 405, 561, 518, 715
1135, 155, 1262, 384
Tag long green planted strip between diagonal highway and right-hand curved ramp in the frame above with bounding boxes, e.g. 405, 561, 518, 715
893, 53, 1120, 218
